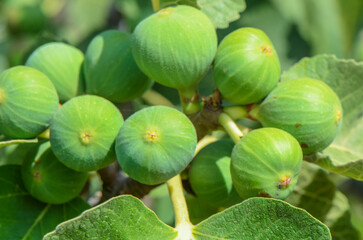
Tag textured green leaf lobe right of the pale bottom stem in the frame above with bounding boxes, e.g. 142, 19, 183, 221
193, 198, 331, 240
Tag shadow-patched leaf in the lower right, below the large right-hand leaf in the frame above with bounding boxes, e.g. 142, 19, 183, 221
286, 162, 359, 240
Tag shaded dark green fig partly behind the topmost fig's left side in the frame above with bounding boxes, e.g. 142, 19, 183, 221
84, 30, 152, 102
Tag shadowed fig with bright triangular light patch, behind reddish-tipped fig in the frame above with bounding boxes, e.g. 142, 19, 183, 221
189, 140, 242, 207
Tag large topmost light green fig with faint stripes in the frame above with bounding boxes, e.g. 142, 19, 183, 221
132, 5, 217, 90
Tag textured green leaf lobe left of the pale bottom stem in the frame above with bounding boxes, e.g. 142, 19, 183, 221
44, 195, 177, 240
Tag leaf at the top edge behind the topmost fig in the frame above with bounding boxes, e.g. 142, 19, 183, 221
160, 0, 246, 28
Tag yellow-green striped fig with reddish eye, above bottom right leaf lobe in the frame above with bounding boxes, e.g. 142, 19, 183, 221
231, 128, 303, 199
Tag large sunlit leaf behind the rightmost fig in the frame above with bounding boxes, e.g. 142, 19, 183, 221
281, 55, 363, 180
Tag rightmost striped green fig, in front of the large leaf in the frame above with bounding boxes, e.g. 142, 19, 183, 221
256, 78, 343, 155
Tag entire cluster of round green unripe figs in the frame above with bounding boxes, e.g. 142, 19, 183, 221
0, 2, 343, 208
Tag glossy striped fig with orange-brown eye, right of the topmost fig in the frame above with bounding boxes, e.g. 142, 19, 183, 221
213, 28, 281, 105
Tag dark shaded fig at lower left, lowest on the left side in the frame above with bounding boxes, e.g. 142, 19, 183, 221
22, 142, 88, 204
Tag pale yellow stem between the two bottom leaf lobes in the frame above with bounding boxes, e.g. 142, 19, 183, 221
167, 174, 193, 239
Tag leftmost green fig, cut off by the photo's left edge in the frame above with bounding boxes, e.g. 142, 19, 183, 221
0, 66, 58, 138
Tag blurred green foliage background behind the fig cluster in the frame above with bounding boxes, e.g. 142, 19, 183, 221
0, 0, 363, 235
